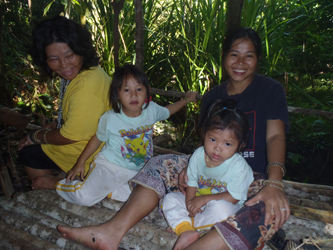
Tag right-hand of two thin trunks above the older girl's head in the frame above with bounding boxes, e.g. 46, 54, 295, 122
134, 0, 145, 69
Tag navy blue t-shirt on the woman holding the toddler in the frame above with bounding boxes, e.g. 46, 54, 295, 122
199, 74, 289, 173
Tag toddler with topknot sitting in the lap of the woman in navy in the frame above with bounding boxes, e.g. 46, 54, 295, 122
163, 100, 253, 249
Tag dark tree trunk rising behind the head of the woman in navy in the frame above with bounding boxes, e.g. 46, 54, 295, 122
222, 0, 244, 82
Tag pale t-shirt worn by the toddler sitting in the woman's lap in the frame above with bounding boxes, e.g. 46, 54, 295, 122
187, 146, 253, 204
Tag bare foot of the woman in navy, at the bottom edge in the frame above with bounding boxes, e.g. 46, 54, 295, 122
57, 224, 120, 250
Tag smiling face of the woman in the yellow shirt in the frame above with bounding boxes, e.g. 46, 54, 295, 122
45, 42, 83, 80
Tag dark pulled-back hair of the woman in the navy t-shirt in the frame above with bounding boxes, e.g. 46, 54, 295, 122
222, 27, 262, 62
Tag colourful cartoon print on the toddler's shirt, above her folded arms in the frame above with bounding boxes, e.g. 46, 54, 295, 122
196, 175, 228, 196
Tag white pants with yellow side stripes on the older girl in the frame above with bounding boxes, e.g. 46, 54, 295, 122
56, 153, 138, 206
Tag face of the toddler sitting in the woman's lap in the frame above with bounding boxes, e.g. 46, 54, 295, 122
204, 129, 239, 168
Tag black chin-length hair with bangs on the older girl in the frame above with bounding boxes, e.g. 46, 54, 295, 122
109, 64, 150, 113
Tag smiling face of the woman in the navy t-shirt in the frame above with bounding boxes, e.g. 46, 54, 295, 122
224, 38, 258, 86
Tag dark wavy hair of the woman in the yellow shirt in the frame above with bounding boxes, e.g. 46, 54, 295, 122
30, 16, 99, 78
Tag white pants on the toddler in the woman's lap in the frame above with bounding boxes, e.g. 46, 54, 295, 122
163, 192, 241, 232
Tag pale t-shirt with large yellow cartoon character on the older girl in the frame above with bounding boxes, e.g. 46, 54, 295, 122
96, 102, 170, 170
